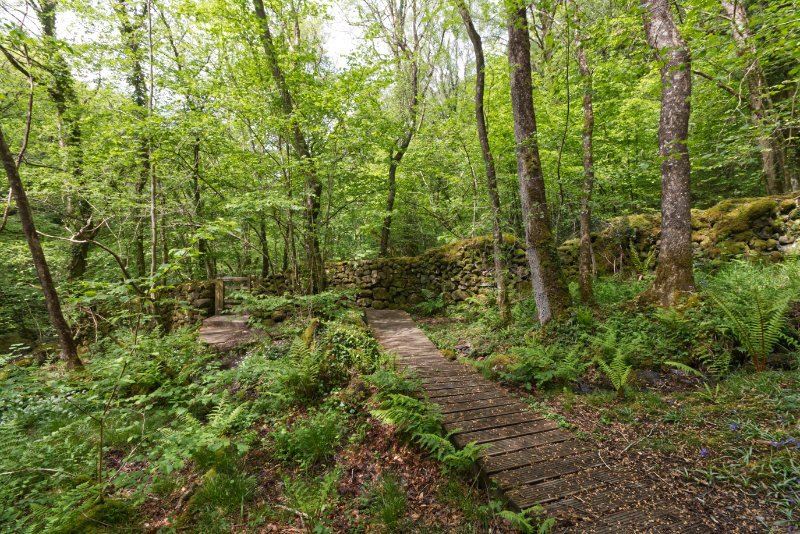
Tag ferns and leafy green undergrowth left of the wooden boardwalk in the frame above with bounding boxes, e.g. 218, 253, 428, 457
0, 293, 536, 533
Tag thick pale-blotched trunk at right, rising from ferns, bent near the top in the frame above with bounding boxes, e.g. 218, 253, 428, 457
642, 0, 694, 306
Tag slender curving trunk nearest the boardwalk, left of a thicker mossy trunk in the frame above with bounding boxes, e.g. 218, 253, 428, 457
458, 0, 511, 324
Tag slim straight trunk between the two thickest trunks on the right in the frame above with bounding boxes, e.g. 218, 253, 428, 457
570, 0, 595, 306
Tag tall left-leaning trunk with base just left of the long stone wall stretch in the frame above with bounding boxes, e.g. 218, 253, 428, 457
253, 0, 326, 293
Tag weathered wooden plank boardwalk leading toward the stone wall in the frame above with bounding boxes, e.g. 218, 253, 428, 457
366, 310, 710, 534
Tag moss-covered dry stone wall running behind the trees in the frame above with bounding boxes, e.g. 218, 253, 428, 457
165, 195, 800, 326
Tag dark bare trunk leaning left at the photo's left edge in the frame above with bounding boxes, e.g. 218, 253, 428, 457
0, 129, 83, 369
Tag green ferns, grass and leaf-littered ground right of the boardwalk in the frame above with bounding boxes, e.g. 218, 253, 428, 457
421, 258, 800, 531
